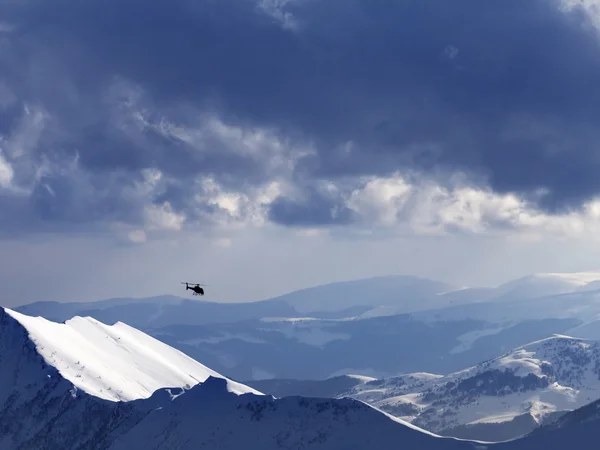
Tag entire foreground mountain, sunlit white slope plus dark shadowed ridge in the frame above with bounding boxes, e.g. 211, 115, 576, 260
0, 309, 488, 450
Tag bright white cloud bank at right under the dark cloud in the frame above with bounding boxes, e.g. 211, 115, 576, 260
338, 175, 600, 236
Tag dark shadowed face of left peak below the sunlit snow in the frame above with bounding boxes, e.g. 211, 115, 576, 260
0, 309, 147, 450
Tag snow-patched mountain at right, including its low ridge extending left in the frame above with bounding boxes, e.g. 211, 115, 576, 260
248, 335, 600, 441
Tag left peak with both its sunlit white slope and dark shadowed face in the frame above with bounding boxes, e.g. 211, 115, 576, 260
0, 308, 261, 450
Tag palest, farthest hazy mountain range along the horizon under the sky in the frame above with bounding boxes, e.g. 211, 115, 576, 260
15, 272, 600, 328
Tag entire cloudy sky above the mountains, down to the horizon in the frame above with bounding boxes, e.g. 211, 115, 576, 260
0, 0, 600, 306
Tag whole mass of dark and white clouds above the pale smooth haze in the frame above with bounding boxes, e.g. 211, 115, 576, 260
0, 0, 600, 242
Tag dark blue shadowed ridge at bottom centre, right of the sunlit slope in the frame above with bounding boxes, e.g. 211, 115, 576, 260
110, 378, 482, 450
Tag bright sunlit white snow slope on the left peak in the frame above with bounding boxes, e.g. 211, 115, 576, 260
5, 309, 260, 401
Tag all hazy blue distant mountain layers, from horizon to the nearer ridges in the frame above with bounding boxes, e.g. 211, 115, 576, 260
16, 272, 600, 380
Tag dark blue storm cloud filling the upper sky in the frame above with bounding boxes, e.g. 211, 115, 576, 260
0, 0, 600, 232
